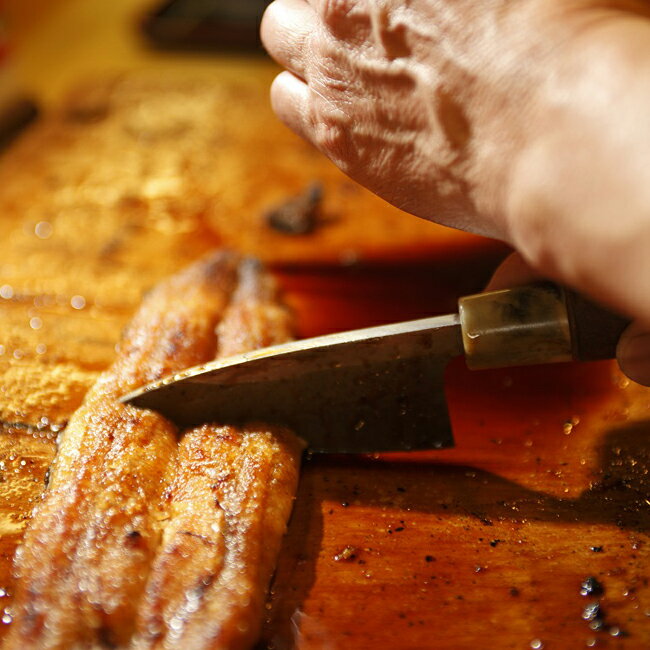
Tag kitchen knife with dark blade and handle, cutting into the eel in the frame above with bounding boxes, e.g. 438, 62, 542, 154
122, 283, 629, 453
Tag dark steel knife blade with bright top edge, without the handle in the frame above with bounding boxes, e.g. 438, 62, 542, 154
125, 314, 463, 453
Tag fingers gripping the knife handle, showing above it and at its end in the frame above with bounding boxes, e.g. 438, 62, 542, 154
485, 253, 650, 386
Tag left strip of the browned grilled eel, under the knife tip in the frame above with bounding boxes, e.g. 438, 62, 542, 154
5, 253, 239, 650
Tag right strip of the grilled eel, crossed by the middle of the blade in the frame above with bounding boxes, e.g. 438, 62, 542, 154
133, 260, 302, 650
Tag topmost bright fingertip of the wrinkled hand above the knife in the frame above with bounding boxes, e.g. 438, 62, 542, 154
260, 0, 318, 79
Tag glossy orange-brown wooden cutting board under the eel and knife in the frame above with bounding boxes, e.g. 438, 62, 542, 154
0, 76, 650, 650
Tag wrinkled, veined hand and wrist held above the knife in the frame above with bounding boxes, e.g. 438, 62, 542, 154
262, 0, 650, 382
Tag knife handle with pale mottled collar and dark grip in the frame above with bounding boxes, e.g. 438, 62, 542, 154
459, 282, 630, 370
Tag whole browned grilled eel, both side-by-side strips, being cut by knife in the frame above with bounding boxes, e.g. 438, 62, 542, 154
5, 253, 300, 649
